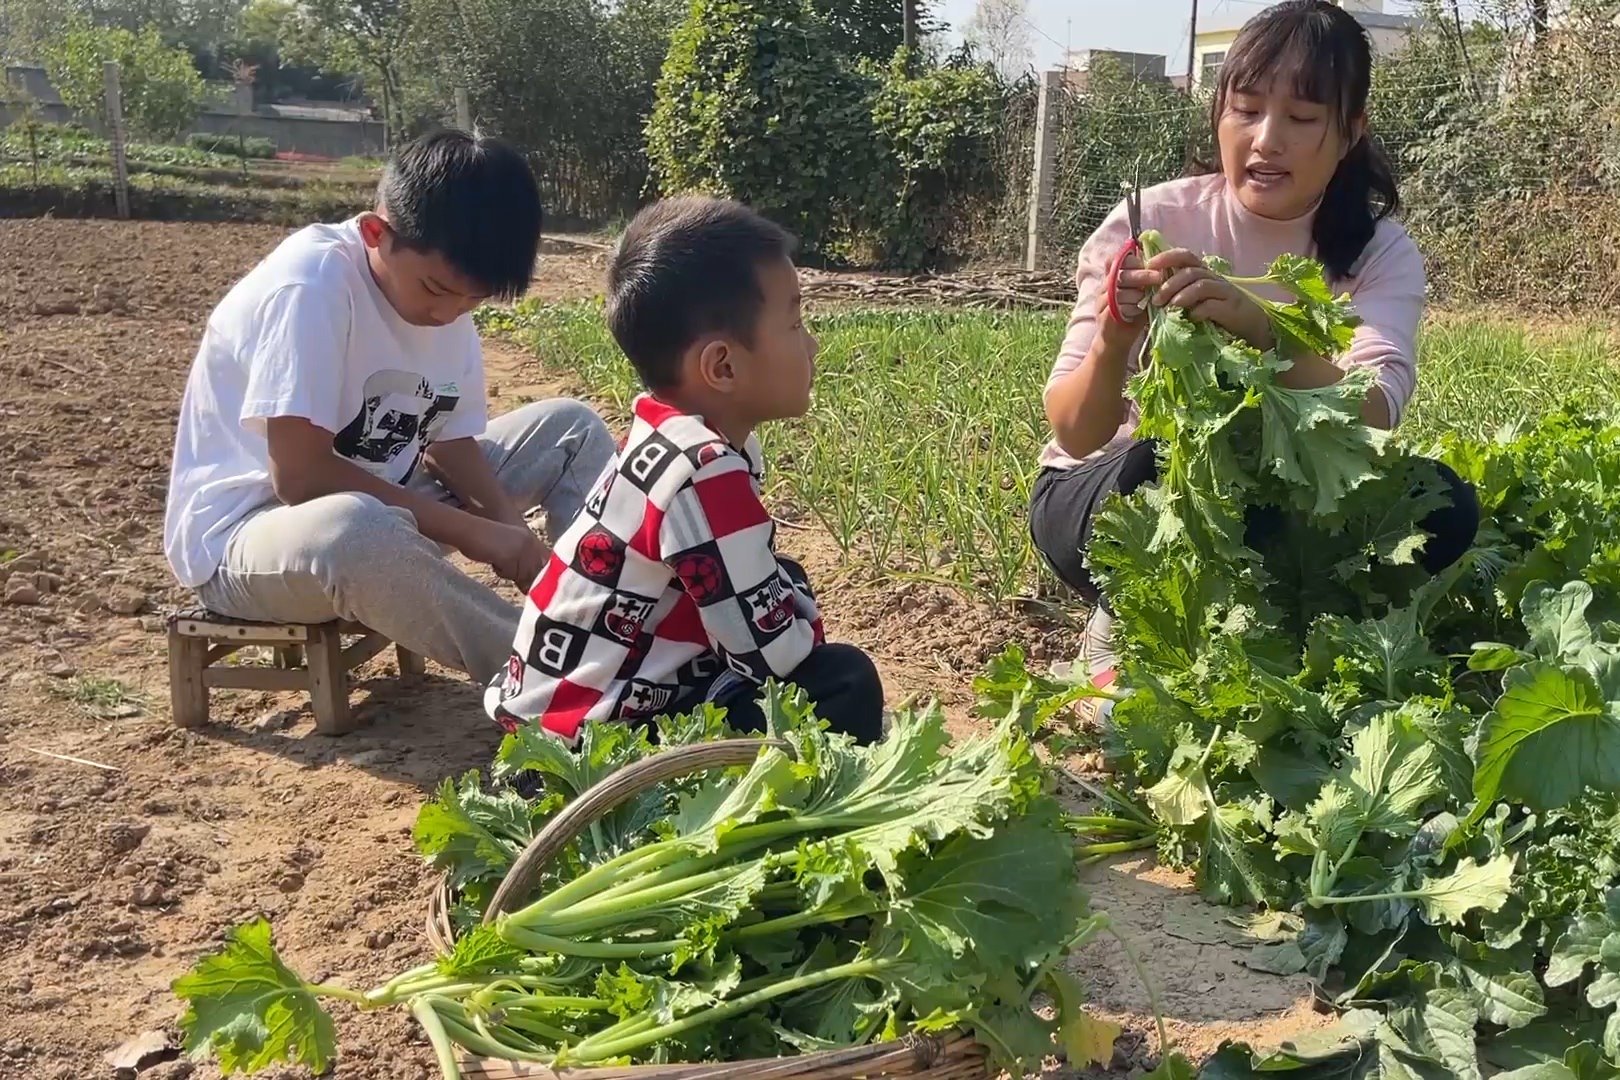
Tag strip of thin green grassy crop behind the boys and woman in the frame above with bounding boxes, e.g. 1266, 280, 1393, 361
481, 301, 1620, 599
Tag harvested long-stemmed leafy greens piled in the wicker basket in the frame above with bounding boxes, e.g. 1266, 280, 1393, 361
173, 683, 1105, 1077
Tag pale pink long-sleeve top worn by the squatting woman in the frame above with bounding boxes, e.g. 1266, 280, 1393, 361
1040, 173, 1427, 468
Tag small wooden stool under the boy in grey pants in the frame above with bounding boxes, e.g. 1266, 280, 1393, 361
168, 609, 428, 735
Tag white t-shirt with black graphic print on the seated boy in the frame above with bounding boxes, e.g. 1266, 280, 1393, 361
164, 219, 488, 588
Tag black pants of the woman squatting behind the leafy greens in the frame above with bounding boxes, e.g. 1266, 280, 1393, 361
1029, 439, 1479, 614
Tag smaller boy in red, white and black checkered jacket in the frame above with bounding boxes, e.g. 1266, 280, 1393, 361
484, 198, 883, 742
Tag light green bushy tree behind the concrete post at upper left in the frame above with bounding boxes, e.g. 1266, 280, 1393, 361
44, 21, 204, 139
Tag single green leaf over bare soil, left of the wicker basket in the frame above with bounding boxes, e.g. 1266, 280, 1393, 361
172, 918, 337, 1075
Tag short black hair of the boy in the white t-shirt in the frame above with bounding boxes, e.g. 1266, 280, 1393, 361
377, 131, 544, 300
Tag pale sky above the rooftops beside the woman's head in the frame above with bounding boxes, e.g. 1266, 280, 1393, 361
936, 0, 1445, 74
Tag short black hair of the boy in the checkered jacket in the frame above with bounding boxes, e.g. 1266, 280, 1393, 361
608, 194, 795, 390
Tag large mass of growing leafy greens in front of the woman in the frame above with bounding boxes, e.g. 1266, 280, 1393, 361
980, 235, 1620, 1078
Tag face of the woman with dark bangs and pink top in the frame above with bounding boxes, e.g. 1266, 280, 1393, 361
1215, 78, 1364, 220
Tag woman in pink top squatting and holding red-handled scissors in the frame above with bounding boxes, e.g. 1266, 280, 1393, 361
1030, 0, 1479, 702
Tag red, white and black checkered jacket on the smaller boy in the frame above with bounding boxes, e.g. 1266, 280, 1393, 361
484, 393, 823, 742
